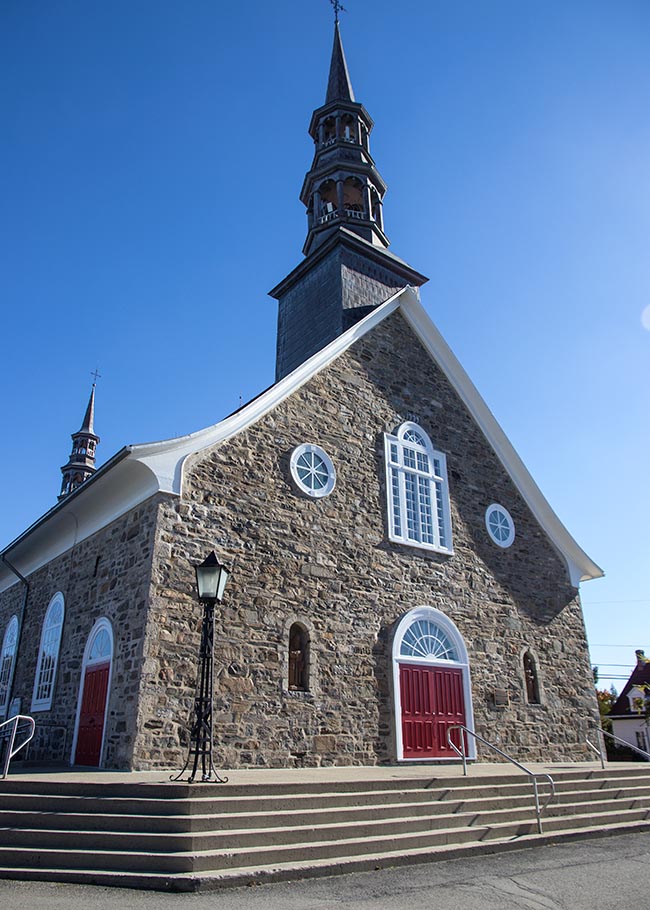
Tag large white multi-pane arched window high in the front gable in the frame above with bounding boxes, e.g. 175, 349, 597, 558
384, 423, 453, 553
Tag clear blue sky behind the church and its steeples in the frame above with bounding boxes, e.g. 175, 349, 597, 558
0, 0, 650, 689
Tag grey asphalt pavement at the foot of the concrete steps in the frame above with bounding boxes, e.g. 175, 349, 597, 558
0, 833, 650, 910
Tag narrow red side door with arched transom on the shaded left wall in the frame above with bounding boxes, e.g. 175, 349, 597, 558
72, 618, 113, 767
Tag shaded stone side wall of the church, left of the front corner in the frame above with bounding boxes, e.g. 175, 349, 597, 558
0, 499, 157, 768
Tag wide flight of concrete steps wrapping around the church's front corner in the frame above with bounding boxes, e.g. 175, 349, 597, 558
0, 764, 650, 891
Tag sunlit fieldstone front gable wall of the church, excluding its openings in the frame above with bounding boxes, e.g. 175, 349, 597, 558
134, 312, 597, 768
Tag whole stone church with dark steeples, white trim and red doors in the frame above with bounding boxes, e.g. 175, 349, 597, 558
0, 23, 602, 769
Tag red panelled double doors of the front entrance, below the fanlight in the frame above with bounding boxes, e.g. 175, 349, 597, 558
399, 664, 465, 758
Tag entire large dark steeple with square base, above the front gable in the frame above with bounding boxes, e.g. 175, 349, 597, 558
270, 17, 428, 382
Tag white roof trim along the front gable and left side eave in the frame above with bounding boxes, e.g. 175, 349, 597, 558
0, 287, 603, 589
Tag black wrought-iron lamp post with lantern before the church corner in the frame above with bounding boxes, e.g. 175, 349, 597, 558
172, 552, 230, 784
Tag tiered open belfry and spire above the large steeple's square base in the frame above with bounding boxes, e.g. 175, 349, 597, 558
300, 21, 388, 256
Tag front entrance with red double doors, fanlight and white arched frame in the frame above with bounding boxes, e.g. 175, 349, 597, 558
393, 607, 475, 761
